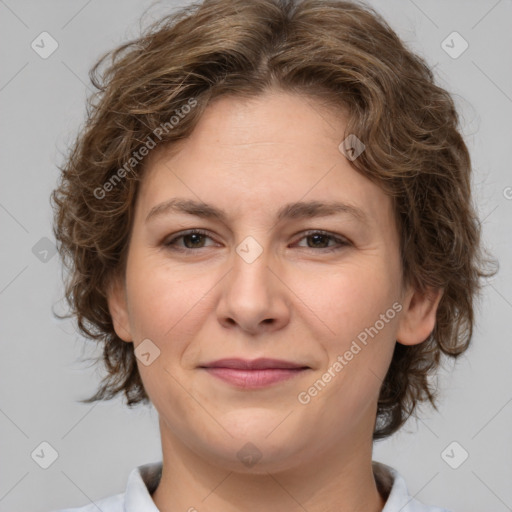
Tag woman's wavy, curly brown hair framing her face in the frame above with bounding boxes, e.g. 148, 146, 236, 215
51, 0, 496, 439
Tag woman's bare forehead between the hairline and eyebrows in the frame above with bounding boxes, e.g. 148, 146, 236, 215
135, 92, 390, 229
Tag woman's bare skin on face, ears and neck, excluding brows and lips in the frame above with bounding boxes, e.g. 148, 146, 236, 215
108, 90, 441, 512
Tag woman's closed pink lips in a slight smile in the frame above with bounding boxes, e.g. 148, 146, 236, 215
199, 358, 311, 389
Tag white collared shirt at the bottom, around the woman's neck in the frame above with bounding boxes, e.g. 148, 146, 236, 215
55, 462, 450, 512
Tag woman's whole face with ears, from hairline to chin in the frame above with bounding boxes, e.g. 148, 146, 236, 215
109, 91, 435, 472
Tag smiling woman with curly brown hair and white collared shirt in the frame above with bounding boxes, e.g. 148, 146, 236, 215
52, 0, 490, 512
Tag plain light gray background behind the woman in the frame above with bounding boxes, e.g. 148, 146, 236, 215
0, 0, 512, 512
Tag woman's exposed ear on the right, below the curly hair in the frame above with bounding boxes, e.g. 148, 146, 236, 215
396, 288, 444, 345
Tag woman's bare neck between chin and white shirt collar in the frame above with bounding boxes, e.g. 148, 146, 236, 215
152, 422, 385, 512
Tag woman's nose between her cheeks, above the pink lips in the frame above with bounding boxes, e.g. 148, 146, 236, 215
217, 244, 290, 335
